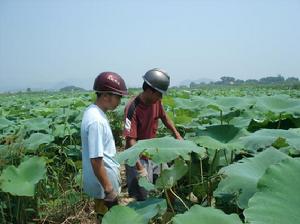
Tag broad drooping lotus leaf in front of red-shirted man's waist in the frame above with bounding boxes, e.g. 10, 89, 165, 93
117, 137, 206, 166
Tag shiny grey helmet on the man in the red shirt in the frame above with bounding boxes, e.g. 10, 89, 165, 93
143, 68, 170, 93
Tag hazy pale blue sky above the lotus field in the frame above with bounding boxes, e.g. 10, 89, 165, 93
0, 0, 300, 91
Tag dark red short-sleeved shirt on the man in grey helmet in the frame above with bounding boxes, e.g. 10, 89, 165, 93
124, 96, 166, 140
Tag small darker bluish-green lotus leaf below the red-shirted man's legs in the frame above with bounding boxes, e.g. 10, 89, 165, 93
127, 198, 167, 223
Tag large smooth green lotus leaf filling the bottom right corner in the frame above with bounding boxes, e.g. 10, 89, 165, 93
244, 158, 300, 224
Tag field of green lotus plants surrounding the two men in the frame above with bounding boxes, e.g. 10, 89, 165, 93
0, 86, 300, 224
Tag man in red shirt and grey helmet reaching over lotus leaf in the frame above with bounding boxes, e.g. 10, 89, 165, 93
124, 68, 182, 201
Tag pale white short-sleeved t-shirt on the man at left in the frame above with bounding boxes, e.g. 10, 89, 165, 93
81, 104, 120, 198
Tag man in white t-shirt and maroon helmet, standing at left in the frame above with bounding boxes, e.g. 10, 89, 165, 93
81, 72, 127, 220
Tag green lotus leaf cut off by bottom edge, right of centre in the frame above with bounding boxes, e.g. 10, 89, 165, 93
172, 205, 242, 224
